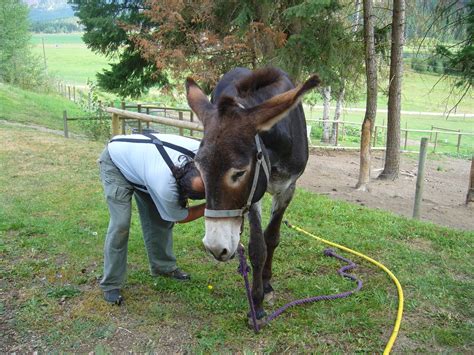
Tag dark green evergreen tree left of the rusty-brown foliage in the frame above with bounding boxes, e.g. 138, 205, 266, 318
71, 0, 168, 97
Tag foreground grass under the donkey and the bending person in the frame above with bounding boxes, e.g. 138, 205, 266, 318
0, 123, 474, 353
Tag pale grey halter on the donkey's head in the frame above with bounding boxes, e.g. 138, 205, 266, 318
204, 134, 270, 218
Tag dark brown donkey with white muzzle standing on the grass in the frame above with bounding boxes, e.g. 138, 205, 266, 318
186, 68, 319, 322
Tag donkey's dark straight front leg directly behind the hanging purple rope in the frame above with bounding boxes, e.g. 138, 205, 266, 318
248, 202, 267, 319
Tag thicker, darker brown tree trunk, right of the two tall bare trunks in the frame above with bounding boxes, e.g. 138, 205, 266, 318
379, 0, 405, 180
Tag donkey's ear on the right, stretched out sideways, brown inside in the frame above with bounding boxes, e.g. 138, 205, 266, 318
247, 75, 320, 131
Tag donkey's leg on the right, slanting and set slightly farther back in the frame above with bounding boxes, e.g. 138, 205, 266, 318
262, 182, 295, 303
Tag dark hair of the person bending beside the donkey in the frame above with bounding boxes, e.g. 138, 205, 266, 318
172, 155, 205, 208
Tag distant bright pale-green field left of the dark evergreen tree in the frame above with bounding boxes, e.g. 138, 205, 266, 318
32, 33, 111, 86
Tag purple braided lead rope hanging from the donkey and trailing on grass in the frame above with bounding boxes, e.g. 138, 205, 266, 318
238, 245, 362, 333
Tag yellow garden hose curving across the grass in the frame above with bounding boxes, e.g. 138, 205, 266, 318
285, 221, 403, 355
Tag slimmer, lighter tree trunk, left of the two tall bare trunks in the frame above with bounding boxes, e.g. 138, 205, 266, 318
356, 0, 377, 191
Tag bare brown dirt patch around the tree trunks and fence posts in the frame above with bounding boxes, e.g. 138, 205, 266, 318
298, 151, 474, 230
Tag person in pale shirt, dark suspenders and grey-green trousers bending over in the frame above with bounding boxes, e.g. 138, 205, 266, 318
99, 134, 205, 305
